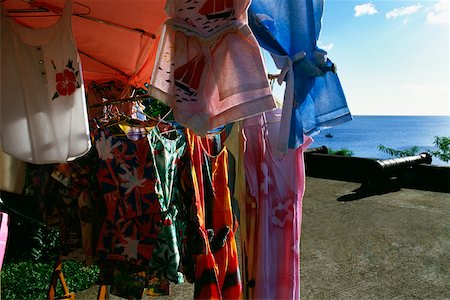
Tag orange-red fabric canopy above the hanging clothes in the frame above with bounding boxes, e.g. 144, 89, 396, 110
1, 0, 167, 87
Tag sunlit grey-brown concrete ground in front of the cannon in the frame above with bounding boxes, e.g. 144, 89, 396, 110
76, 177, 450, 300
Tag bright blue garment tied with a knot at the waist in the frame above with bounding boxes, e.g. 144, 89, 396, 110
248, 0, 352, 151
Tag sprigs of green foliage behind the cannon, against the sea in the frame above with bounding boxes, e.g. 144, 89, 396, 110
378, 136, 450, 162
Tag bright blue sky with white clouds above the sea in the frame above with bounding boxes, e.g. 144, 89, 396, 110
268, 0, 450, 115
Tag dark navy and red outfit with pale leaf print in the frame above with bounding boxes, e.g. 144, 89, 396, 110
94, 128, 161, 265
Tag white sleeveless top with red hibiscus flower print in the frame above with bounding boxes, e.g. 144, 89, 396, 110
0, 0, 91, 164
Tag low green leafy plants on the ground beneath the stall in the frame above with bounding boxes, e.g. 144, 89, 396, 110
1, 260, 99, 300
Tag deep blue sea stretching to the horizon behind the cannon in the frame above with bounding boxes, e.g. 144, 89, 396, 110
310, 116, 450, 166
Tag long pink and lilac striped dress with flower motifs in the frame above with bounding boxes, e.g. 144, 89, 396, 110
243, 109, 312, 299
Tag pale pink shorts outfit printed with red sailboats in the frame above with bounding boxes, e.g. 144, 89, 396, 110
149, 0, 275, 136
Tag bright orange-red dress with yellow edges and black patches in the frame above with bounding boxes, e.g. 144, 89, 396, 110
187, 130, 242, 299
